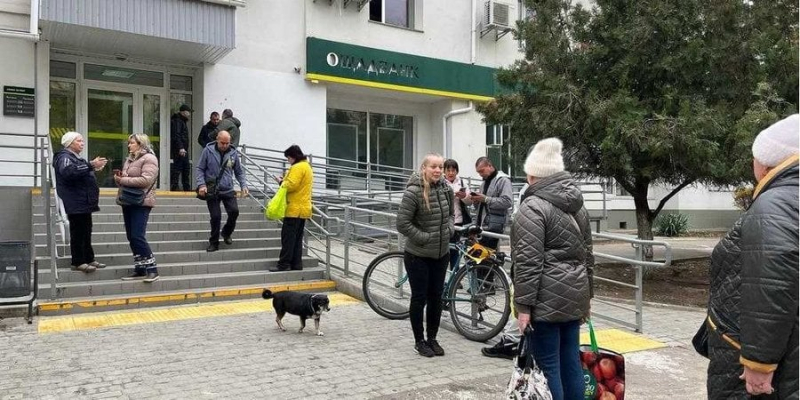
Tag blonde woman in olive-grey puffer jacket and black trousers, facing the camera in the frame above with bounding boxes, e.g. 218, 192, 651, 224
397, 154, 455, 357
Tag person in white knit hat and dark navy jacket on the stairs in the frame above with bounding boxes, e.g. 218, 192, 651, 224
53, 132, 108, 272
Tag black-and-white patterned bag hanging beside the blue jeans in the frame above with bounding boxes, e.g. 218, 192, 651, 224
506, 326, 553, 400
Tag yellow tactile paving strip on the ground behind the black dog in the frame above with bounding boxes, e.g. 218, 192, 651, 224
38, 293, 360, 334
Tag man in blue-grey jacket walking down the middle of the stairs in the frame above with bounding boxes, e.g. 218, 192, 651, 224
196, 131, 249, 252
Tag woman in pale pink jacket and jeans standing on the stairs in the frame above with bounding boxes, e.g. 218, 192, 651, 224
114, 133, 158, 282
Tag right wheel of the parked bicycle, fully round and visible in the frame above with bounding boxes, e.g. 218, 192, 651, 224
448, 264, 511, 342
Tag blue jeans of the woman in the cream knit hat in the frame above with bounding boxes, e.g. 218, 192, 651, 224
531, 321, 584, 400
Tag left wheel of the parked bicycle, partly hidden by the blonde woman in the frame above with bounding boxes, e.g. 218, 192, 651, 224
361, 251, 411, 319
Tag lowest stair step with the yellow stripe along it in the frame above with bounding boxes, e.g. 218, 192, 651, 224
39, 278, 336, 316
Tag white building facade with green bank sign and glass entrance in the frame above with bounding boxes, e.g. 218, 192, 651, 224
0, 0, 731, 239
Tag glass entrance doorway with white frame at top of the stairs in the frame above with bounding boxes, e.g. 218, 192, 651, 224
83, 84, 163, 187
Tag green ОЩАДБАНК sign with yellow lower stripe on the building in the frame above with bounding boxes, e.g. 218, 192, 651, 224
306, 37, 495, 101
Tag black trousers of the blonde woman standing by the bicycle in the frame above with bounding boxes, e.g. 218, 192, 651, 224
403, 252, 450, 342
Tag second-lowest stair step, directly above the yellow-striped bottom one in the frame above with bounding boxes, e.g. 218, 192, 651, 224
39, 266, 325, 300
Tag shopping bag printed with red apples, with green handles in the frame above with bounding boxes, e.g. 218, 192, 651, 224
580, 320, 625, 400
